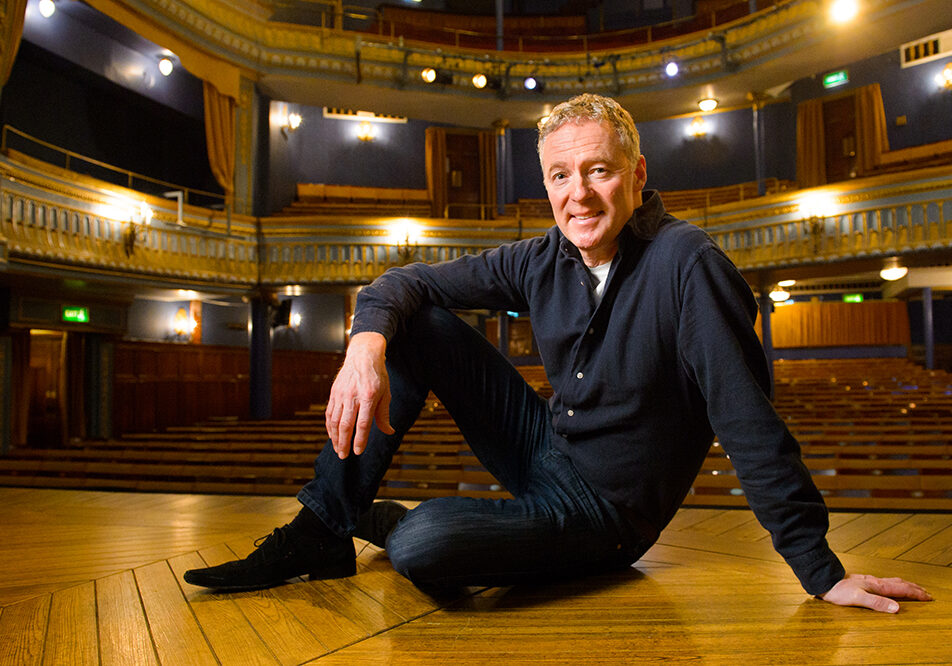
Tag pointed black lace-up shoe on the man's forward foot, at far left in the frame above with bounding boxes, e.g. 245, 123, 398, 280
184, 525, 357, 592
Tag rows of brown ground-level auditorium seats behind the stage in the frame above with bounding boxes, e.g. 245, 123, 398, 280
0, 359, 952, 510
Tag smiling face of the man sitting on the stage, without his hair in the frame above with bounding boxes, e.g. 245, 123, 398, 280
542, 120, 646, 266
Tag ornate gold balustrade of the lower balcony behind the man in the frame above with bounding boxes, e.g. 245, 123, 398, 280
0, 150, 952, 288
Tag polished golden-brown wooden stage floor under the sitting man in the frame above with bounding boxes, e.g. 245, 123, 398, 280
0, 488, 952, 665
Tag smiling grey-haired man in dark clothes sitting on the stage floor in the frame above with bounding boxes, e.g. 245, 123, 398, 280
185, 95, 930, 612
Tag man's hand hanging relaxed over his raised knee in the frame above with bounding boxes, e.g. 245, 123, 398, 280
324, 332, 393, 460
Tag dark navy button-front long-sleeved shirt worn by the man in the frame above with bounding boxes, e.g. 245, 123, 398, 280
352, 192, 844, 594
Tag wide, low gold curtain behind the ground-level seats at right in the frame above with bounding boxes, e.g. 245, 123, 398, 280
770, 301, 910, 349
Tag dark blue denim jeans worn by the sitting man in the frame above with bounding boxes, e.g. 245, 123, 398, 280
298, 306, 651, 587
